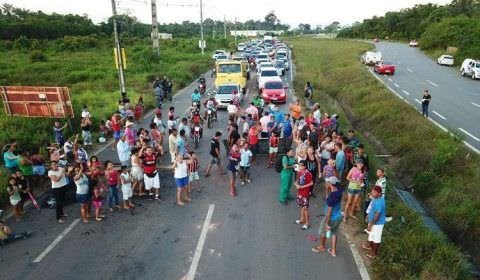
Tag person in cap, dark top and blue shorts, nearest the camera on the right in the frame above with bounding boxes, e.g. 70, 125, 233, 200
312, 177, 343, 257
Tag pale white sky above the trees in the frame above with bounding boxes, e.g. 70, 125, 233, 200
0, 0, 451, 27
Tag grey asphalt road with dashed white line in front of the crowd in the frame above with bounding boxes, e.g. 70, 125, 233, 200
0, 53, 361, 280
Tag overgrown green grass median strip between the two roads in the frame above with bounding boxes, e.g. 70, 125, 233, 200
291, 38, 480, 279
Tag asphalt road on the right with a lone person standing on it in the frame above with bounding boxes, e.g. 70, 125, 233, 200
372, 42, 480, 153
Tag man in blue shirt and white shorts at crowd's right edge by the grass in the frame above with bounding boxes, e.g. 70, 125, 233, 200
362, 186, 386, 259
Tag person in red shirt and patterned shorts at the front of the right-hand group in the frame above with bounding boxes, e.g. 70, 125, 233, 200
295, 160, 313, 230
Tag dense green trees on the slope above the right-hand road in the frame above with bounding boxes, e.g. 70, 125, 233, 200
338, 0, 480, 57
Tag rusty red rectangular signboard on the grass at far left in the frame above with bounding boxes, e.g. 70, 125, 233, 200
0, 86, 74, 118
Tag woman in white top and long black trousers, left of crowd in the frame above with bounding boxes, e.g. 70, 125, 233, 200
48, 161, 68, 224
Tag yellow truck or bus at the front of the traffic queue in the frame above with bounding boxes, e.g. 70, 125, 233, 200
215, 60, 247, 93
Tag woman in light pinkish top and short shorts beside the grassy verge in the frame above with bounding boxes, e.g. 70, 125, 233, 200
343, 160, 364, 222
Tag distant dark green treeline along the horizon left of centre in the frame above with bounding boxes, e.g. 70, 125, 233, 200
0, 4, 289, 41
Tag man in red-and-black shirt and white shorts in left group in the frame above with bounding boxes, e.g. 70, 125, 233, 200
139, 144, 160, 200
